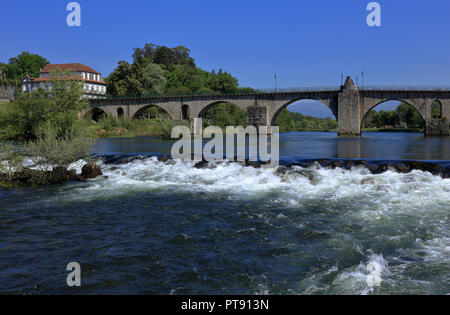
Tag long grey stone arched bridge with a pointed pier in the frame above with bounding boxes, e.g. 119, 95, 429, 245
86, 77, 450, 136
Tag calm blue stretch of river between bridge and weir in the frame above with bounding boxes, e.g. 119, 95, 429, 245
94, 132, 450, 160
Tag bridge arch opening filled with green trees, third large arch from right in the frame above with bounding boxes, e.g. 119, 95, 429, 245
199, 102, 246, 128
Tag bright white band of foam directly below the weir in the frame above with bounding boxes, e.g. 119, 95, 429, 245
60, 157, 450, 202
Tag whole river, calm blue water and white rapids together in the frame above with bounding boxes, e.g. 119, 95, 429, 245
0, 133, 450, 294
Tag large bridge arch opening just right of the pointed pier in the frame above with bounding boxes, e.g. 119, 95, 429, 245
361, 100, 425, 132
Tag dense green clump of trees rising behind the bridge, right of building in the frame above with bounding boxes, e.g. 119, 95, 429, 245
106, 44, 254, 97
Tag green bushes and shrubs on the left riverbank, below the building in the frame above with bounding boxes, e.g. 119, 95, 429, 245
0, 72, 99, 187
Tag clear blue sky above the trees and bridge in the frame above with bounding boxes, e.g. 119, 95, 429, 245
0, 0, 450, 116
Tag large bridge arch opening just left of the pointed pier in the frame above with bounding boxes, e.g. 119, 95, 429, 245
272, 100, 338, 132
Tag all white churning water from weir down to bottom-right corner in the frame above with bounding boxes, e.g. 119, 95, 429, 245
5, 157, 450, 294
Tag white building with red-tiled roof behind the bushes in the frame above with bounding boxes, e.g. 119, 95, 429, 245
22, 63, 107, 98
